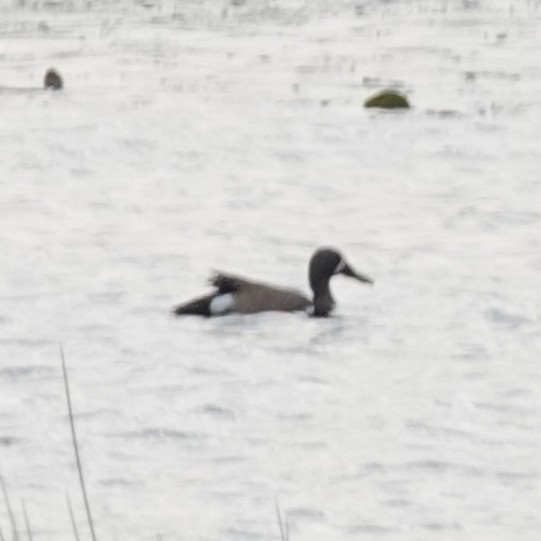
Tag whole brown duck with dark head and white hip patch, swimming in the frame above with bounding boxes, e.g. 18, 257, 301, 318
173, 248, 374, 317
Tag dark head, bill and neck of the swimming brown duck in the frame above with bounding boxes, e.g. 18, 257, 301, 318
308, 248, 374, 317
